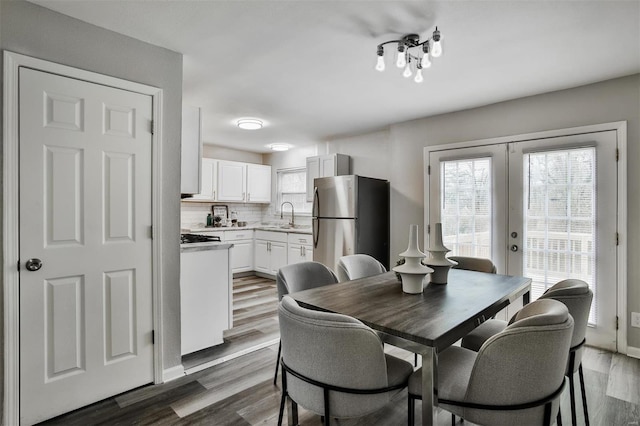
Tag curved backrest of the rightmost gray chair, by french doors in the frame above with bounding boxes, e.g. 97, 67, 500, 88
538, 279, 593, 373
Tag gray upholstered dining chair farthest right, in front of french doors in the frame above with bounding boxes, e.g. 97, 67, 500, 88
462, 279, 593, 425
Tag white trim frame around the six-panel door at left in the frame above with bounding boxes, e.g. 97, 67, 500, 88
2, 50, 163, 424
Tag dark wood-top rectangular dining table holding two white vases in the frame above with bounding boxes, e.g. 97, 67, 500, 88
290, 269, 531, 425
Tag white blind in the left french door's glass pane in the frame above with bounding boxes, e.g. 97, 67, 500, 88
440, 157, 492, 259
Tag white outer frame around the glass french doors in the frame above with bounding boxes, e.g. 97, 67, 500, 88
423, 121, 629, 355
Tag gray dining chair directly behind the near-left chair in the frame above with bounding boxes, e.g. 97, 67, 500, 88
273, 262, 338, 385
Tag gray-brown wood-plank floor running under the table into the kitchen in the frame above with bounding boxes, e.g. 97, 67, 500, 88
45, 277, 640, 426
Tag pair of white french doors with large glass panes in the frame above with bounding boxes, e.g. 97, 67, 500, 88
428, 130, 618, 350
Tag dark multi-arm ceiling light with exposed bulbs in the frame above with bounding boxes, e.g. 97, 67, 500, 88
376, 27, 442, 83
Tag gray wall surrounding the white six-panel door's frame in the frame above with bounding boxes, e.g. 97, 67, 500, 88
0, 1, 182, 412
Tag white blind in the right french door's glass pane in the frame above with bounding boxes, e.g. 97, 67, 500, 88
523, 147, 597, 323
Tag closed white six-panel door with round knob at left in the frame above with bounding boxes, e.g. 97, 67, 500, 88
19, 68, 153, 424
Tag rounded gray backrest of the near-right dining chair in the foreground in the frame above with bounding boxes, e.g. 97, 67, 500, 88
463, 299, 573, 425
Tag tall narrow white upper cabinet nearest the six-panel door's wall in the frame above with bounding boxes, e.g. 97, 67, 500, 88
180, 107, 202, 194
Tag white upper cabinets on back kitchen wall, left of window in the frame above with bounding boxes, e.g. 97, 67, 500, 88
188, 158, 271, 203
